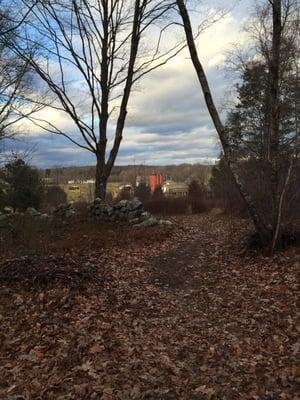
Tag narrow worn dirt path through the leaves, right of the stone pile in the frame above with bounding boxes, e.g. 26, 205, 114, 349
152, 215, 244, 289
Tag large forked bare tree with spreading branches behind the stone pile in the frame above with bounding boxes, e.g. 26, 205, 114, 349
12, 0, 185, 198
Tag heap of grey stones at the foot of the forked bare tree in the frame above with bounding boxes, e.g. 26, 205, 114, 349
89, 198, 172, 227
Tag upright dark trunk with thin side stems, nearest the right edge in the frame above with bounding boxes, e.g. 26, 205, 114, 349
262, 0, 300, 253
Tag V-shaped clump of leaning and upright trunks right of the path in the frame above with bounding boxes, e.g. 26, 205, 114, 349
177, 0, 299, 252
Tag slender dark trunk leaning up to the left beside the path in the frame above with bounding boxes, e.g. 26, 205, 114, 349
177, 0, 271, 247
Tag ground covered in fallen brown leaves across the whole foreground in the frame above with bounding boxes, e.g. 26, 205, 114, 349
0, 214, 300, 400
